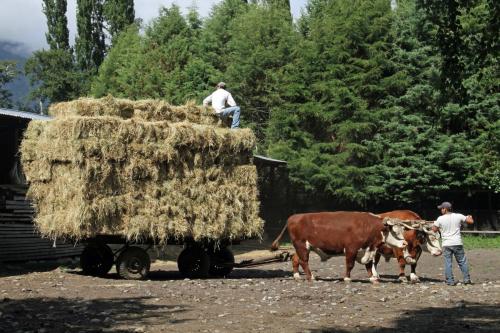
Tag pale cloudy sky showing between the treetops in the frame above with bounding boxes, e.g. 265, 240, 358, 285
0, 0, 307, 52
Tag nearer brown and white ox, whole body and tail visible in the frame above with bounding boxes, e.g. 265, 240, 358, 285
271, 211, 406, 282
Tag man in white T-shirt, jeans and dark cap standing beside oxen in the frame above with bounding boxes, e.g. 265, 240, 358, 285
432, 202, 474, 286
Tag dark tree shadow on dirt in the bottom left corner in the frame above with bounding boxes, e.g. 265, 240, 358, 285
0, 297, 188, 333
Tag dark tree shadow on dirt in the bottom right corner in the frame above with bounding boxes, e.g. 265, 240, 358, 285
309, 302, 500, 333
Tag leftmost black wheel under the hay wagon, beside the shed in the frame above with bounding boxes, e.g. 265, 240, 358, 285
80, 243, 114, 277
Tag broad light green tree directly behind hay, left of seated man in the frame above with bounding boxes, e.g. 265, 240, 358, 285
92, 6, 217, 104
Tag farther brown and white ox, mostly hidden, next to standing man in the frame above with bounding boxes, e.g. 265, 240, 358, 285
372, 210, 443, 282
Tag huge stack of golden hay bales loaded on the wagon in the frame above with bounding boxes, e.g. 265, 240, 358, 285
21, 97, 263, 244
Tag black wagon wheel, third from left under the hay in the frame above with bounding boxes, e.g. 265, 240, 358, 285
177, 246, 210, 279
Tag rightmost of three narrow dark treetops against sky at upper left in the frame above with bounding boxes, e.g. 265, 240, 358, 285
104, 0, 135, 41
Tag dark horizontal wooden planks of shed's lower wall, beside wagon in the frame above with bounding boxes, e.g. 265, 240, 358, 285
0, 185, 83, 262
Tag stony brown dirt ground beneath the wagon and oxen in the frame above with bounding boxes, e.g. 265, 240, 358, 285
0, 243, 500, 333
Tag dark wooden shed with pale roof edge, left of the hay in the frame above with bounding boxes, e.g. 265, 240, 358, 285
0, 108, 82, 262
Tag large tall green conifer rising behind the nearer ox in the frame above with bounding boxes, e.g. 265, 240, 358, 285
267, 0, 399, 205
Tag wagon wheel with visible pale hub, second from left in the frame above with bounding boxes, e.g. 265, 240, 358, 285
116, 246, 151, 280
